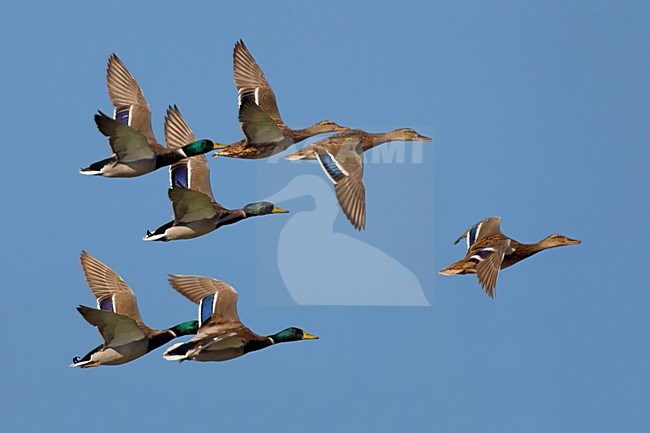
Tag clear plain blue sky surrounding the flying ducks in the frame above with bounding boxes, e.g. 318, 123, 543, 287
0, 1, 650, 432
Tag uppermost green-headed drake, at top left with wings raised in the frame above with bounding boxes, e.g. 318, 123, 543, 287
79, 54, 225, 177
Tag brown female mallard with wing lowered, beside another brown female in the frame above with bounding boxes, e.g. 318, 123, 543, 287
285, 128, 431, 230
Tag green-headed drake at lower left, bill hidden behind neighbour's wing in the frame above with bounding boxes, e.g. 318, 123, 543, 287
70, 251, 199, 368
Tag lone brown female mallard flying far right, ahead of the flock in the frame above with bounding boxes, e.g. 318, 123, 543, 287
439, 217, 580, 298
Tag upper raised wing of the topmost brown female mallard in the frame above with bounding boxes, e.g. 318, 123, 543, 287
233, 40, 282, 121
